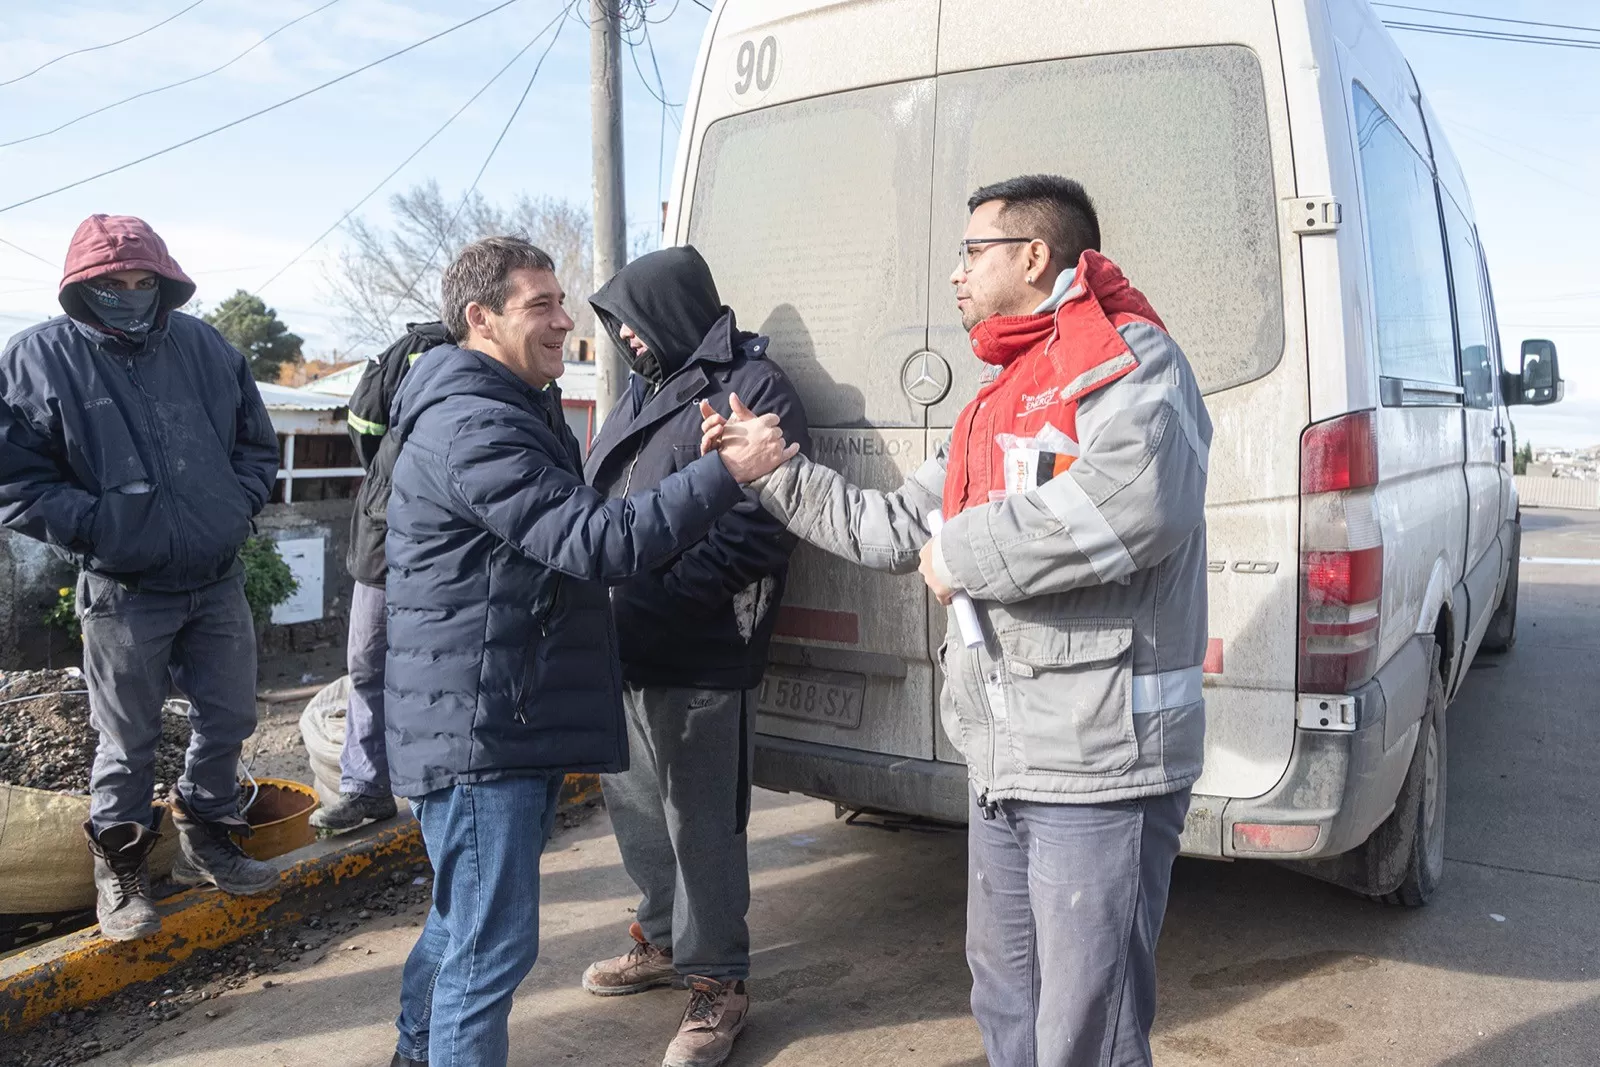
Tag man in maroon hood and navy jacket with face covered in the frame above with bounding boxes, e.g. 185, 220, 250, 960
0, 214, 278, 941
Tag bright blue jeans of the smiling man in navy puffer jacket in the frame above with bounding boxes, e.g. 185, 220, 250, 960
395, 774, 562, 1067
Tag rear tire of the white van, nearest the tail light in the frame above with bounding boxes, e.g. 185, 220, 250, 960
1358, 648, 1448, 907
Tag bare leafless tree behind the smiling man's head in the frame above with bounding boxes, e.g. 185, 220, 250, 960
326, 181, 594, 346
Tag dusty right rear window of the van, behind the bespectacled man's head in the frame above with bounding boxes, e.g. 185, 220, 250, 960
934, 45, 1283, 392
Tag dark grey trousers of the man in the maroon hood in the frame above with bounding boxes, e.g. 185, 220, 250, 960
77, 573, 256, 835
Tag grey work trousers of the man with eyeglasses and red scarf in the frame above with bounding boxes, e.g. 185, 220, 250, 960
966, 789, 1189, 1067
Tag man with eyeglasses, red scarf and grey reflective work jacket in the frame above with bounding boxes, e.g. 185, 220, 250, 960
702, 174, 1211, 1067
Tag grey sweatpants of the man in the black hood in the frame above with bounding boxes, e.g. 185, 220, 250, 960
600, 686, 755, 982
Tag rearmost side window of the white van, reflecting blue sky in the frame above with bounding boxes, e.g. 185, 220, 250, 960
1355, 85, 1458, 386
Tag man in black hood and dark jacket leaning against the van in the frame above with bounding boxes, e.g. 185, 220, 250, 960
584, 246, 810, 1067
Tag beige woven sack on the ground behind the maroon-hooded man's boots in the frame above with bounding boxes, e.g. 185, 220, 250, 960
0, 784, 178, 915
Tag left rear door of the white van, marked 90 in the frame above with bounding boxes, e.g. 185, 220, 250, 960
677, 3, 942, 760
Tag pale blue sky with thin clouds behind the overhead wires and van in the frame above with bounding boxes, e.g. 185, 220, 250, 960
0, 0, 1600, 448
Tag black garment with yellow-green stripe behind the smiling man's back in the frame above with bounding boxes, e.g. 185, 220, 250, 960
344, 322, 451, 585
